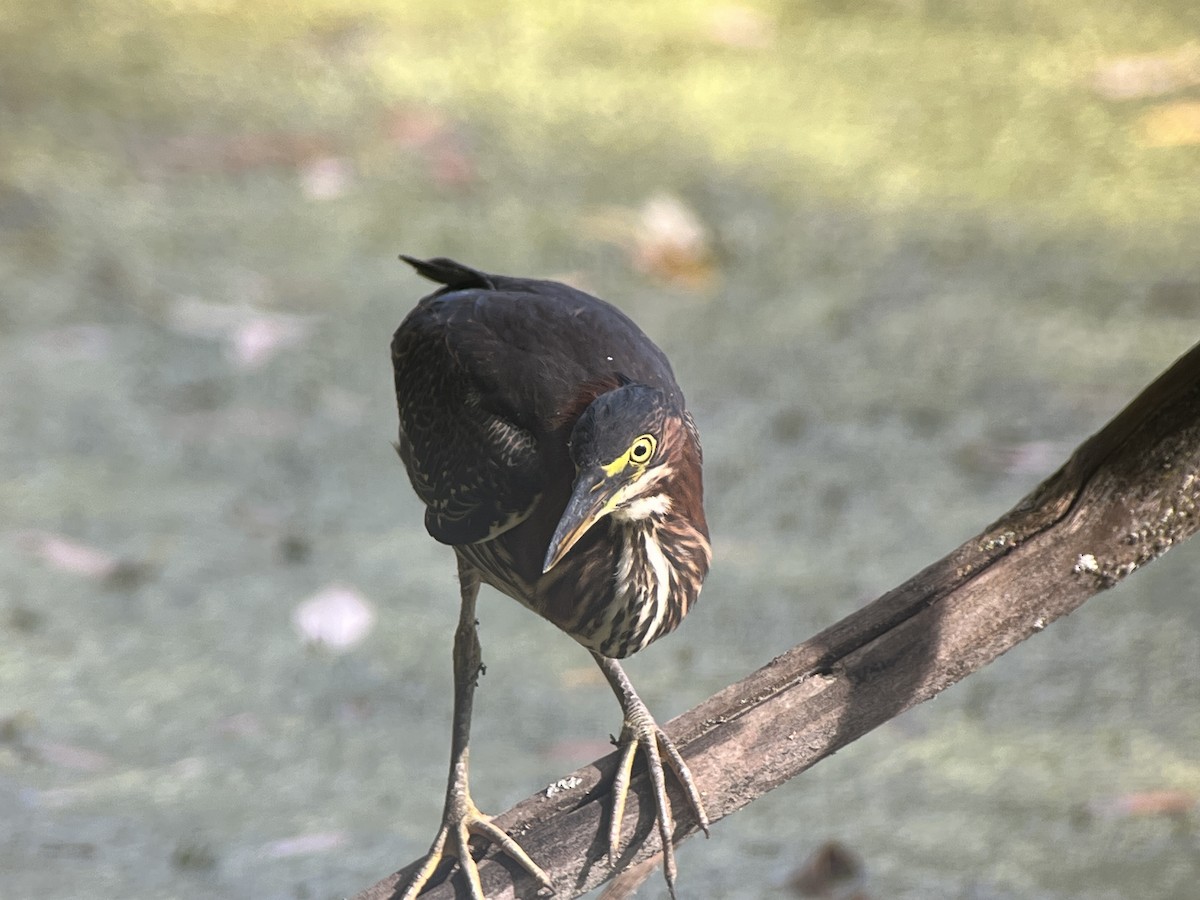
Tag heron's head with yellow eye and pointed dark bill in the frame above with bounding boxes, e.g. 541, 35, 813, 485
542, 384, 700, 572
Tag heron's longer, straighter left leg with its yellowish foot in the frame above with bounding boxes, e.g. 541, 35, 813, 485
401, 559, 554, 900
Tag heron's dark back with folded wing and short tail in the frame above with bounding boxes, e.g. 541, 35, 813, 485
392, 257, 683, 544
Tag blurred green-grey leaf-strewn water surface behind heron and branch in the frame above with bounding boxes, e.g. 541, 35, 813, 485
0, 0, 1200, 900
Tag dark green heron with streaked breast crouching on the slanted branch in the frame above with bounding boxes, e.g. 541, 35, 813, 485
391, 257, 710, 900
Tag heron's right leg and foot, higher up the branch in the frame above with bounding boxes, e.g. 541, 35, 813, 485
592, 652, 708, 898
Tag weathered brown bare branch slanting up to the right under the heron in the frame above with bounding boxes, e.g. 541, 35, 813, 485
354, 346, 1200, 900
